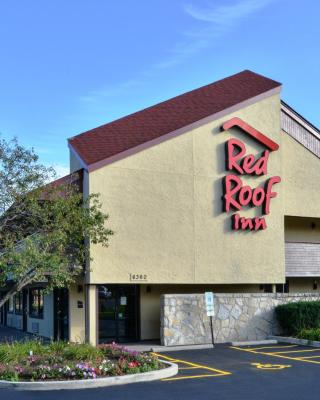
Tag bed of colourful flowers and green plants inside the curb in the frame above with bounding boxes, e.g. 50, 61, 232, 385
0, 341, 166, 382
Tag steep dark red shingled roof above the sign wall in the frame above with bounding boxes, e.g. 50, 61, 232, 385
69, 70, 281, 166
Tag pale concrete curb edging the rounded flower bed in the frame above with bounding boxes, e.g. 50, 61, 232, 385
0, 361, 178, 390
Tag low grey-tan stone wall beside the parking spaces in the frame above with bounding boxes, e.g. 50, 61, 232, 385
161, 293, 320, 346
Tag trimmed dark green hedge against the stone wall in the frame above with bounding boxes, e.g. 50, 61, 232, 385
275, 301, 320, 335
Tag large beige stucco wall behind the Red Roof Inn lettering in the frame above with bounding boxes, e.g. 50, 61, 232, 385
89, 95, 284, 284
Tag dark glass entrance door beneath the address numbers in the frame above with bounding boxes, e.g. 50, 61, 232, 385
98, 285, 139, 343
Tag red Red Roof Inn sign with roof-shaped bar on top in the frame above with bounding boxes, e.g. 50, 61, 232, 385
222, 117, 281, 231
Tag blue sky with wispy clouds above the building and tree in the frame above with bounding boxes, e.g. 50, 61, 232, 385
0, 0, 320, 175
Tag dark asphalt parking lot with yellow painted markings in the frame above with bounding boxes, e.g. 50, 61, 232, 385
0, 344, 320, 400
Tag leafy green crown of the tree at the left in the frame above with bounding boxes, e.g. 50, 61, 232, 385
0, 139, 113, 307
